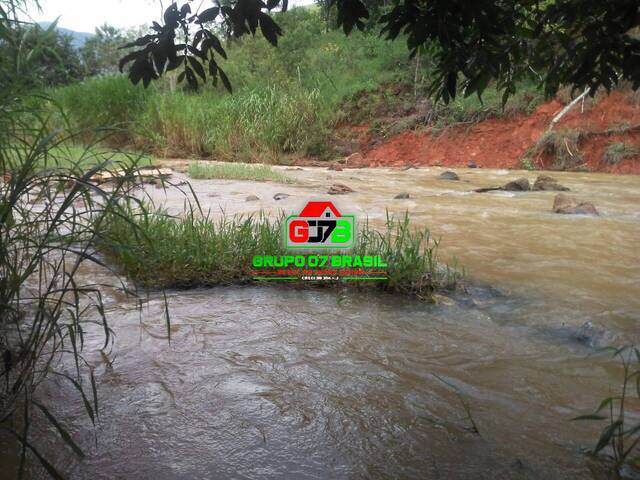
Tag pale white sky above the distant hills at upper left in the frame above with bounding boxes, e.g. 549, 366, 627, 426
29, 0, 312, 33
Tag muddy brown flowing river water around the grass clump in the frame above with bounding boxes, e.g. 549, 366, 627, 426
5, 168, 640, 480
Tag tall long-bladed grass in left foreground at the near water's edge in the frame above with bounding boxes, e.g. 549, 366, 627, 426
0, 99, 158, 478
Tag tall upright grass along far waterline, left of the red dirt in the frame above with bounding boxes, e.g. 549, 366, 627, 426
136, 86, 327, 163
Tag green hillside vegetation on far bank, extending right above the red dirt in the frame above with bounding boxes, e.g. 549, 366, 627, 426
49, 8, 541, 163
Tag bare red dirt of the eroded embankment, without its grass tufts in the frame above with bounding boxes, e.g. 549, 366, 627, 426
340, 91, 640, 174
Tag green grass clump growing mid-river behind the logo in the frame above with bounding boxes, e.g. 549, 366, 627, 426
102, 209, 460, 299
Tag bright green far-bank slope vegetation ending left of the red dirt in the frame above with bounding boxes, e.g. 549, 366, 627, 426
50, 9, 409, 162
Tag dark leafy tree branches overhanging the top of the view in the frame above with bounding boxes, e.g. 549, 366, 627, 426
120, 0, 640, 102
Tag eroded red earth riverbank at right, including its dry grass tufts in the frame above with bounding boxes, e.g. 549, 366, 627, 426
304, 91, 640, 174
